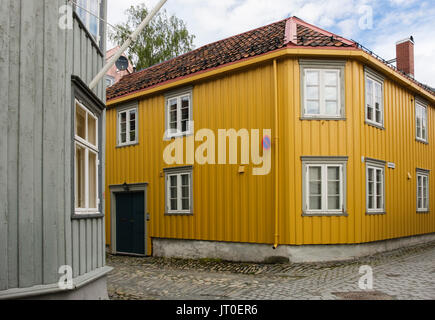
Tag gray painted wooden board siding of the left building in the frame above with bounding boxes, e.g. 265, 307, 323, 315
0, 0, 106, 295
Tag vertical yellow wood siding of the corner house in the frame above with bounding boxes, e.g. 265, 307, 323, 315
105, 58, 435, 253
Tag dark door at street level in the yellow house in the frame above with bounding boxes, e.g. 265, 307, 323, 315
116, 192, 145, 254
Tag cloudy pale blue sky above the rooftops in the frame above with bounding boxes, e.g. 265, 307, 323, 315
108, 0, 435, 87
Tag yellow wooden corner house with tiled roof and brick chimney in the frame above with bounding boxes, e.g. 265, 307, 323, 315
105, 17, 435, 262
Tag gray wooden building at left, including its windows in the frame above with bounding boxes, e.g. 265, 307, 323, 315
0, 0, 110, 299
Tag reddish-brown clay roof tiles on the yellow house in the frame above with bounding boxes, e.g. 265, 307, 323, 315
107, 19, 358, 100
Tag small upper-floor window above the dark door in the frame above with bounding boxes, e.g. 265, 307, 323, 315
118, 107, 138, 146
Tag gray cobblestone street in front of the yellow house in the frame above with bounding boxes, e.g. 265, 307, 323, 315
107, 243, 435, 300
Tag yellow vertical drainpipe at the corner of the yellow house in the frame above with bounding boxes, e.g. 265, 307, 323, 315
273, 59, 279, 249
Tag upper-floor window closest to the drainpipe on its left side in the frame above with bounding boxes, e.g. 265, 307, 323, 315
165, 89, 193, 138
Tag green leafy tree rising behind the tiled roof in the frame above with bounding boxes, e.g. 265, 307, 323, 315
109, 4, 195, 70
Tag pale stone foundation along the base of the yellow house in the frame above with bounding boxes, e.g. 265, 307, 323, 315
152, 233, 435, 263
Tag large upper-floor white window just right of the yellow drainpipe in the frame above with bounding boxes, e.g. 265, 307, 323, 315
299, 60, 345, 119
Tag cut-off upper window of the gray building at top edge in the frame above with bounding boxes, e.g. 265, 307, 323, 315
76, 0, 101, 42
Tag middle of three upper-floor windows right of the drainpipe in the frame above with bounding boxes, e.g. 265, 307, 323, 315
365, 70, 384, 127
